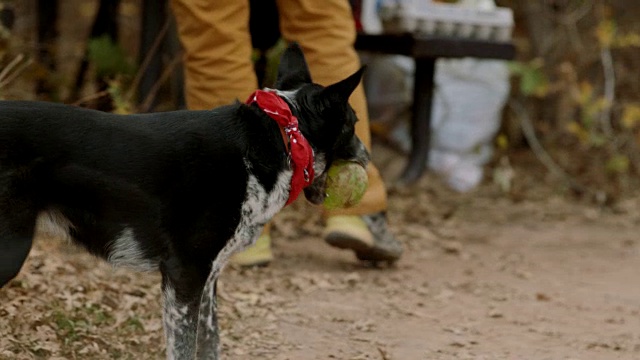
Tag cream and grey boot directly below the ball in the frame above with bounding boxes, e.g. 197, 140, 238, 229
324, 212, 402, 262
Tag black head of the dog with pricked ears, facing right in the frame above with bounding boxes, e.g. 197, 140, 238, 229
275, 43, 369, 204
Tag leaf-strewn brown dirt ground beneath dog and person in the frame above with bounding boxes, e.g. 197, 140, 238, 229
0, 144, 640, 360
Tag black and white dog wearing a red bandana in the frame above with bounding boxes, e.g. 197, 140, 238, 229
0, 44, 369, 359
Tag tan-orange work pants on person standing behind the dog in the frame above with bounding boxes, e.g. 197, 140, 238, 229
171, 0, 387, 215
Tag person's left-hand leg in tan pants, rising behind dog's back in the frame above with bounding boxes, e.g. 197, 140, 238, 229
171, 0, 273, 265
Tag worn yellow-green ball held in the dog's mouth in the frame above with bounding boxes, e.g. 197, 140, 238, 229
323, 161, 369, 210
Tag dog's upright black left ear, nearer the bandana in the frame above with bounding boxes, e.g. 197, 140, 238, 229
276, 42, 311, 90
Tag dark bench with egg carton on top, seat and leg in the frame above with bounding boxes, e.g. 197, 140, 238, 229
355, 34, 516, 184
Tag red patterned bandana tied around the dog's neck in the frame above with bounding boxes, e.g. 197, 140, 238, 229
246, 90, 314, 205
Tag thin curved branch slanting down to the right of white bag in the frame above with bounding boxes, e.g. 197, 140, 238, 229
509, 100, 585, 192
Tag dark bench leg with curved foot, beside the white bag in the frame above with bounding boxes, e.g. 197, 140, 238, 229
400, 59, 436, 184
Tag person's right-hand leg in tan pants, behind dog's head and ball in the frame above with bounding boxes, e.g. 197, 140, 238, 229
277, 0, 402, 261
